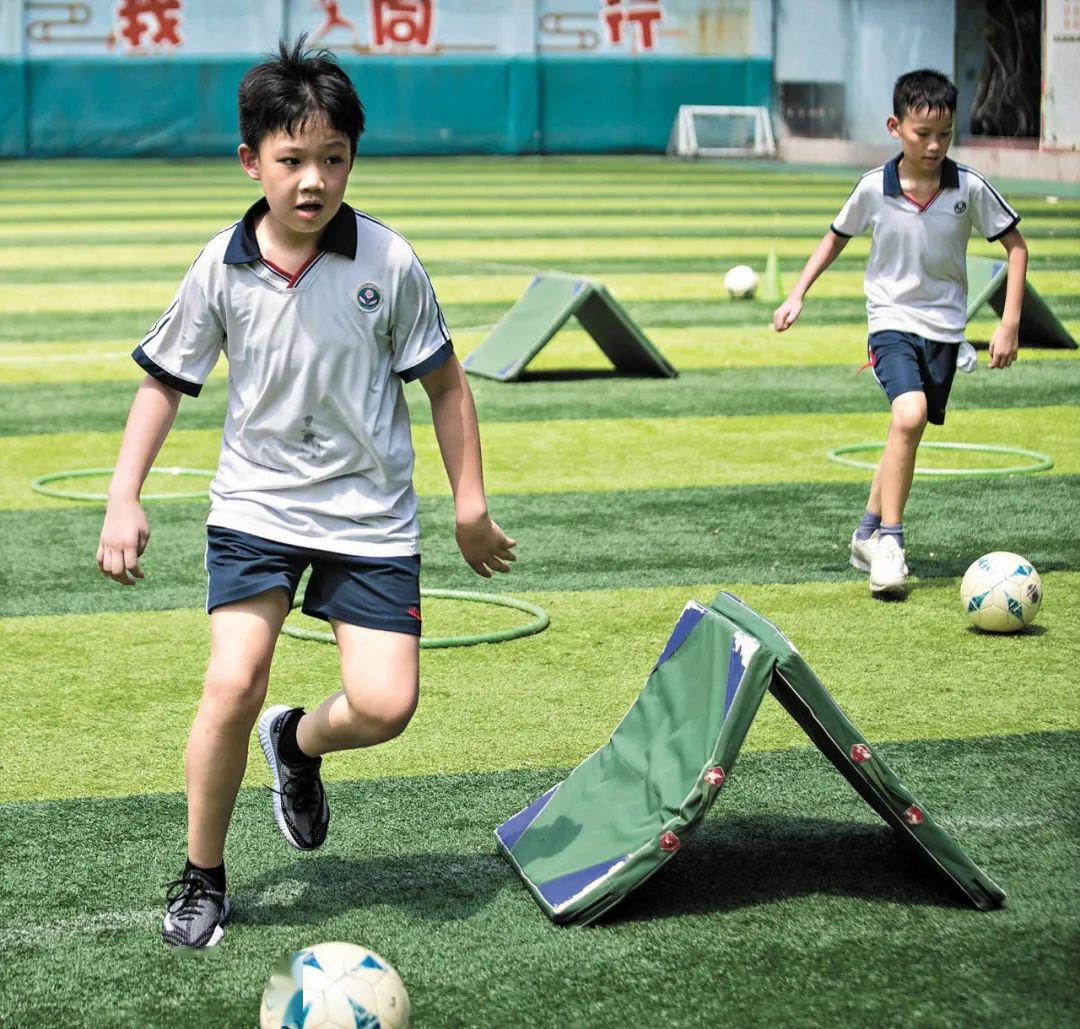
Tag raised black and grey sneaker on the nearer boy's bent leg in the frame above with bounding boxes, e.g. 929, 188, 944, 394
259, 704, 330, 851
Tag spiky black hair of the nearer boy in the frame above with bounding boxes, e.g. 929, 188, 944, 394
238, 35, 364, 157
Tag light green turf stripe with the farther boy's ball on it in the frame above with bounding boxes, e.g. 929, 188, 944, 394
0, 572, 1080, 802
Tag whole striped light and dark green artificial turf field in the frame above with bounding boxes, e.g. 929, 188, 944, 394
0, 157, 1080, 1029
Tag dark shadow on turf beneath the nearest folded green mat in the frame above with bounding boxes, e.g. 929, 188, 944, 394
596, 816, 969, 925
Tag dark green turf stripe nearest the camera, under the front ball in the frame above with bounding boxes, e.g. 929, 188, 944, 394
0, 733, 1077, 1029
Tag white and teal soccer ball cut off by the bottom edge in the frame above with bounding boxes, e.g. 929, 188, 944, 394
259, 944, 409, 1029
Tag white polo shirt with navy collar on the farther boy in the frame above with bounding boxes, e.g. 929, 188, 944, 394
832, 155, 1020, 343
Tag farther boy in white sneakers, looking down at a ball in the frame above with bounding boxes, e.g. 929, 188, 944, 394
772, 69, 1027, 598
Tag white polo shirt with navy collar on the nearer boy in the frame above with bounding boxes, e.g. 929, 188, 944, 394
132, 199, 454, 557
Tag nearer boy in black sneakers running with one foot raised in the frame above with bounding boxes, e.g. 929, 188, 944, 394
97, 37, 515, 947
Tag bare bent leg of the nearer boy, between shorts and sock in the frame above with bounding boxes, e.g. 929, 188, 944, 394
296, 619, 420, 757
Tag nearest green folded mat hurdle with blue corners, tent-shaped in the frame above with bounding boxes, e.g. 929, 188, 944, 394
495, 593, 1004, 924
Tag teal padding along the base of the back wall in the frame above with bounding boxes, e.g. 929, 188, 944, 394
0, 54, 772, 157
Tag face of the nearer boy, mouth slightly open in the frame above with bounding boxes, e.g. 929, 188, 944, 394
238, 119, 352, 235
